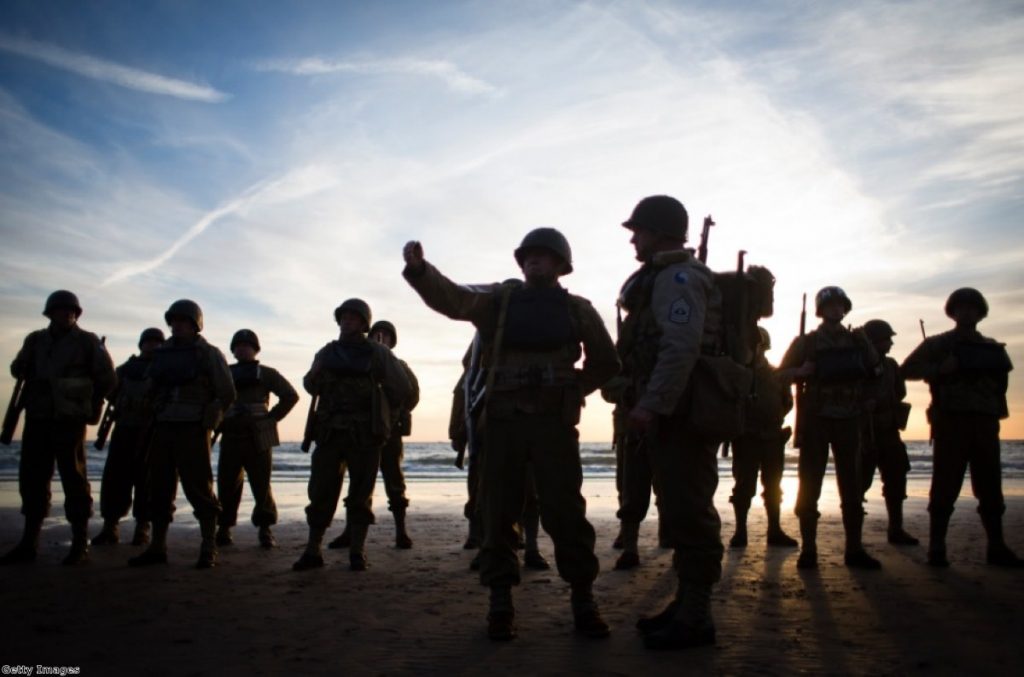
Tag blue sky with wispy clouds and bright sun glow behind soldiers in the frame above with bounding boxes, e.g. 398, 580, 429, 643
0, 0, 1024, 441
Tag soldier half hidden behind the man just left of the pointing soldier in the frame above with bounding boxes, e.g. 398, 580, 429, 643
327, 320, 420, 550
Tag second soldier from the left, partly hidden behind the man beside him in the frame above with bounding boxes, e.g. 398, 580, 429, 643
92, 327, 164, 545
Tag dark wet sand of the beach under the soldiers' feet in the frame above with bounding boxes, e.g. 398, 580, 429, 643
0, 479, 1024, 675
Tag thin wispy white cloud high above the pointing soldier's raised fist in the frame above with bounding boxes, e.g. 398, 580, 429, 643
257, 56, 501, 95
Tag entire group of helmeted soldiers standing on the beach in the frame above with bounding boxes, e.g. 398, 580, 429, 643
2, 196, 1024, 649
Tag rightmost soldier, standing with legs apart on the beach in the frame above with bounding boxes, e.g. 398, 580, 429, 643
901, 288, 1024, 567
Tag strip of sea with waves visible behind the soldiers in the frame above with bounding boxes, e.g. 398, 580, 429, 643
0, 439, 1024, 481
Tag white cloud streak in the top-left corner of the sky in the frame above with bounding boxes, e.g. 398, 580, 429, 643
0, 35, 228, 103
